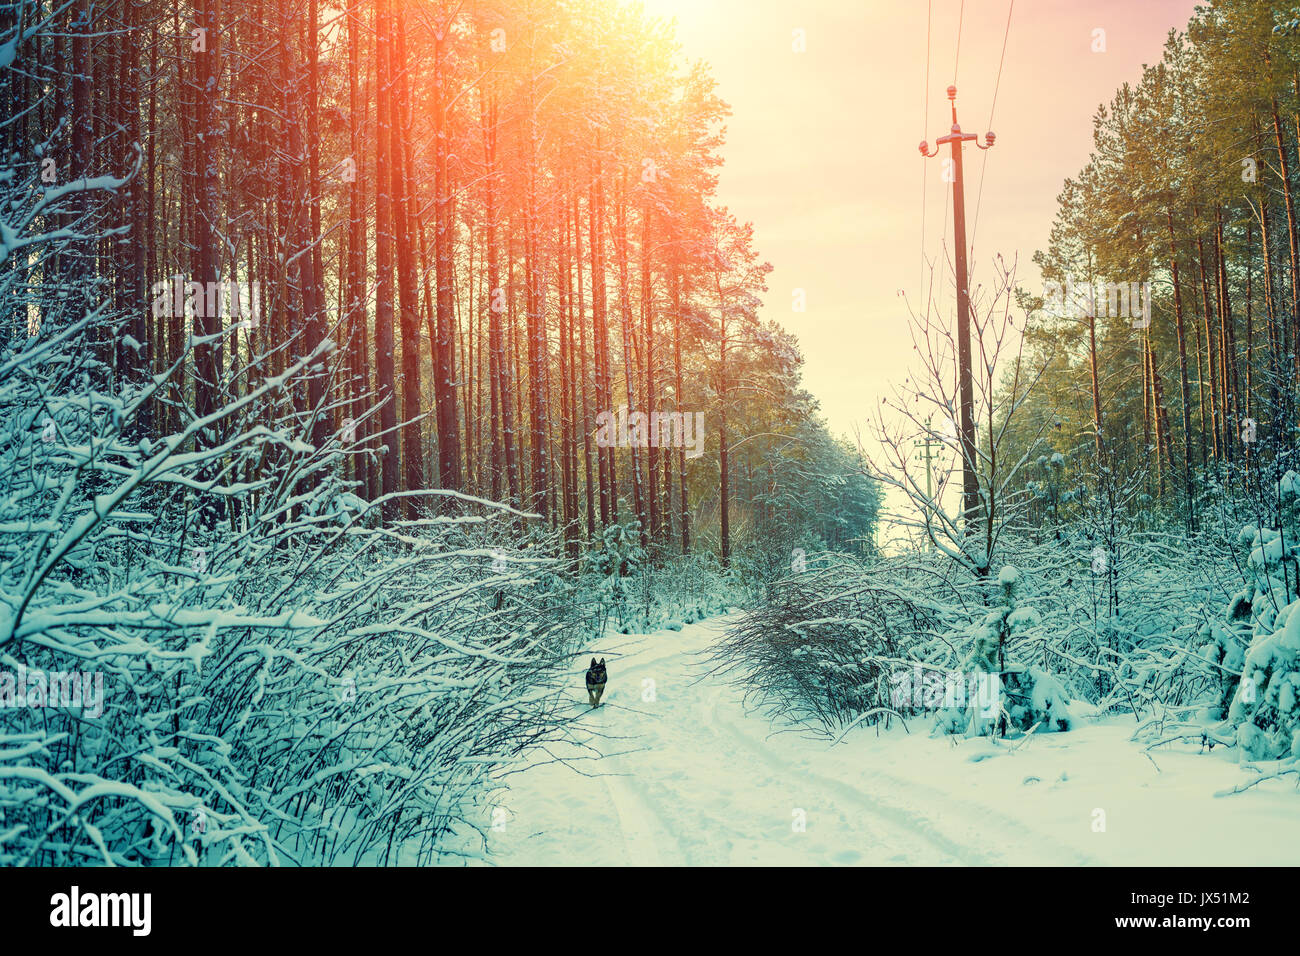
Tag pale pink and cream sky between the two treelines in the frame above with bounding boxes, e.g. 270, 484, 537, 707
644, 0, 1195, 437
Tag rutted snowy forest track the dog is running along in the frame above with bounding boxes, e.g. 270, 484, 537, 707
478, 619, 1088, 865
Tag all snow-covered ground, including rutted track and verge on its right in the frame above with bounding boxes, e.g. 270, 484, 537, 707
467, 618, 1300, 866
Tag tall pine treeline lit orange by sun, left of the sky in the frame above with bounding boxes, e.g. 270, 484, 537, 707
0, 0, 876, 563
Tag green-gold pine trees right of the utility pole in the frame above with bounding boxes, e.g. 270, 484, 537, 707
1009, 0, 1300, 532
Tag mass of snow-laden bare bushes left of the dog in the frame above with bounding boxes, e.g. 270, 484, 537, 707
0, 293, 579, 865
